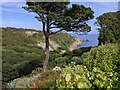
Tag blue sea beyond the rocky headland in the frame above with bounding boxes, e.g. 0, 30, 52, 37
70, 33, 99, 49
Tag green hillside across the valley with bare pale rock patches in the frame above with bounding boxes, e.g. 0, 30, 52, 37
1, 27, 83, 81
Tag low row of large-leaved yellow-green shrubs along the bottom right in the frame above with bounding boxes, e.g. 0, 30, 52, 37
56, 65, 118, 90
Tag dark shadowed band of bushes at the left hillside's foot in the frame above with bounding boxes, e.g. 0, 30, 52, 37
2, 58, 43, 82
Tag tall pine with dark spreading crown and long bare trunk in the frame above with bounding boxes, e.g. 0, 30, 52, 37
23, 0, 94, 72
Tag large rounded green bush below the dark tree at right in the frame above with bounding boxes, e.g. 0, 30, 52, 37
84, 44, 120, 72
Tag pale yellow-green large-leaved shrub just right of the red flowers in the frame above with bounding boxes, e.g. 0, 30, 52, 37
57, 65, 92, 88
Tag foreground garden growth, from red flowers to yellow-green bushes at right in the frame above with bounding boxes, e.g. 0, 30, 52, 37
4, 44, 120, 89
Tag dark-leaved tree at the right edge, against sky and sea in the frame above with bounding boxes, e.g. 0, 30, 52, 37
95, 11, 120, 45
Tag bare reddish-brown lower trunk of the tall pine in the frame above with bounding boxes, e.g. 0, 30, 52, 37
43, 33, 49, 72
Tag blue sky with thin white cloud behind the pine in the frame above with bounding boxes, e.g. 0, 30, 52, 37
0, 2, 118, 34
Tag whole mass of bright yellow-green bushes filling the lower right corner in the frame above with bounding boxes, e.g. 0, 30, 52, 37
56, 44, 120, 89
